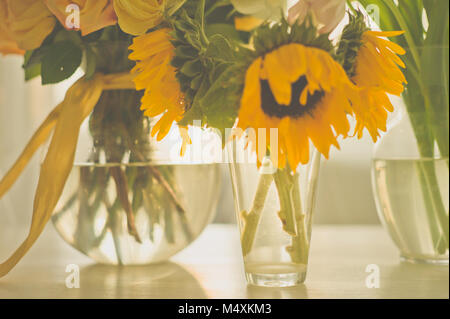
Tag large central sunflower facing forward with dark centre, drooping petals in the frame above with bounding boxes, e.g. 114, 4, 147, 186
238, 43, 358, 170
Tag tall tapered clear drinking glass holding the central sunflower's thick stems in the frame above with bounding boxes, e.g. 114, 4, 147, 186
228, 144, 320, 287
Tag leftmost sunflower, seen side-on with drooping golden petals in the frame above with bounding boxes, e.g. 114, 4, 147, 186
129, 28, 191, 154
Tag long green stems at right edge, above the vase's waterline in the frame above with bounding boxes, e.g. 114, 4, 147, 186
359, 0, 449, 157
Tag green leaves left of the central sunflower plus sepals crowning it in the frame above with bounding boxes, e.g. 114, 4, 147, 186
172, 1, 334, 136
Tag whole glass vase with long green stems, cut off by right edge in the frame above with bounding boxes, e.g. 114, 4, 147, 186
372, 38, 449, 264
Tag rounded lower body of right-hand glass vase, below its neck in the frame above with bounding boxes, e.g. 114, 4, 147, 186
372, 108, 449, 265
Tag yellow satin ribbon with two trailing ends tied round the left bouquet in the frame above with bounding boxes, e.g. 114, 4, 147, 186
0, 73, 135, 277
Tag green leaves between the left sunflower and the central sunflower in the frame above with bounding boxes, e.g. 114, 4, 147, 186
167, 1, 242, 131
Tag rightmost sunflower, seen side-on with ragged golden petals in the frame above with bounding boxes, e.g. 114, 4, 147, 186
352, 31, 407, 141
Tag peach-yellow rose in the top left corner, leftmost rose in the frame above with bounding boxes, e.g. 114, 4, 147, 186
2, 0, 56, 50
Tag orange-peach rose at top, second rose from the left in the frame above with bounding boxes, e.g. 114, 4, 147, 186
44, 0, 117, 36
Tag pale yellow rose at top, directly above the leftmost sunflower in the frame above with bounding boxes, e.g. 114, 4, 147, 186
113, 0, 182, 35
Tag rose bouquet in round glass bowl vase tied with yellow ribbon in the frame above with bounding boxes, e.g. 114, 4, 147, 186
0, 0, 220, 275
